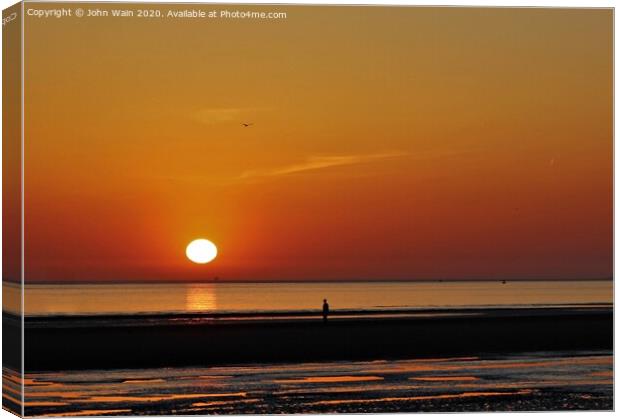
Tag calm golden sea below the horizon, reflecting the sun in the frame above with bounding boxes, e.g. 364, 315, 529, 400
3, 281, 613, 315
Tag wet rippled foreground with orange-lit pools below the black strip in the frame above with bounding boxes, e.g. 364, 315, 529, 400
3, 352, 613, 416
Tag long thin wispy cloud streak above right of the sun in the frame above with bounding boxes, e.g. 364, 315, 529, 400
239, 152, 408, 179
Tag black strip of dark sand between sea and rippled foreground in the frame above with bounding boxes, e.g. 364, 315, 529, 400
3, 306, 613, 372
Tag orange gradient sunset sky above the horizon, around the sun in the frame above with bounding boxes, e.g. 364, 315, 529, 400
25, 3, 613, 281
